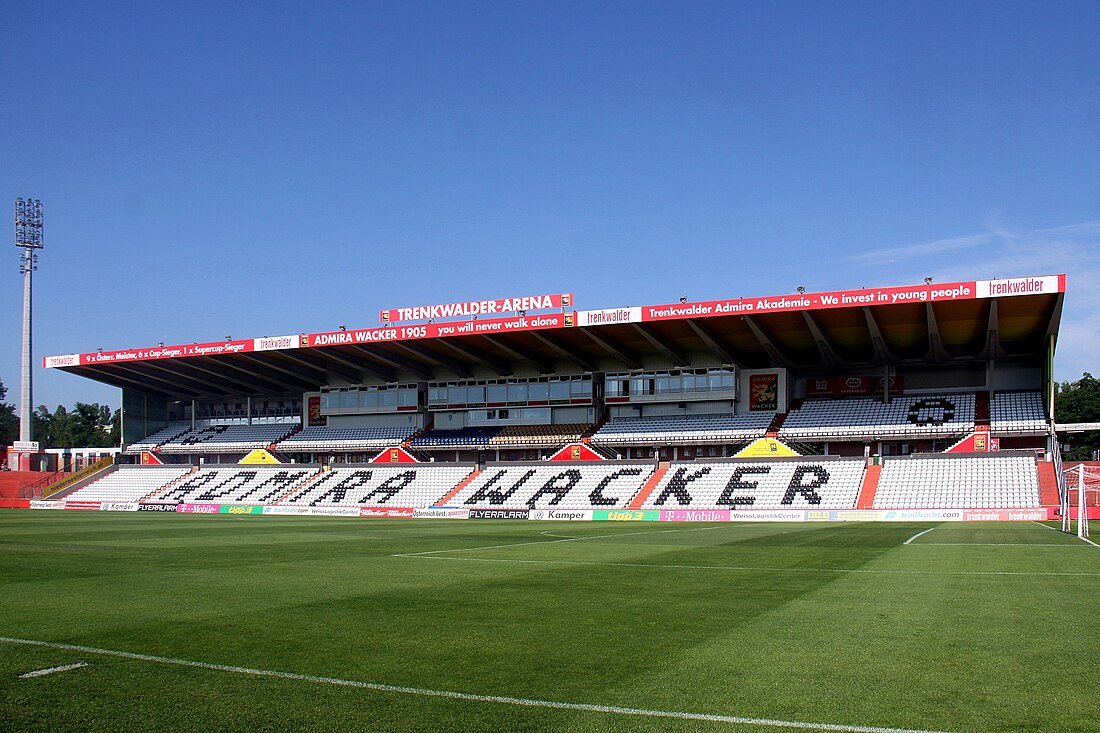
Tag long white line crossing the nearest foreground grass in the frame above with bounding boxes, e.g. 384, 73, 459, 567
0, 636, 963, 733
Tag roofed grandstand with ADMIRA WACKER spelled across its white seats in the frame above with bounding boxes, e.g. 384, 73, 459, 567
25, 275, 1065, 514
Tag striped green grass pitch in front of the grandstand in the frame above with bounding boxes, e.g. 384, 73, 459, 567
0, 511, 1100, 733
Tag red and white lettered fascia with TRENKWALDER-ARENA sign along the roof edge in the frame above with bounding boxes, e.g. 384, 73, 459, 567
43, 274, 1066, 369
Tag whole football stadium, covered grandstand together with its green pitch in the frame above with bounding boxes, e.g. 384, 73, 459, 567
0, 274, 1100, 733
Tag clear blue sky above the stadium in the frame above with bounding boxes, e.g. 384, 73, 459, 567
0, 0, 1100, 408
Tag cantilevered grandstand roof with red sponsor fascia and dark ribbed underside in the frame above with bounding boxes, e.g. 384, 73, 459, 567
43, 274, 1066, 400
